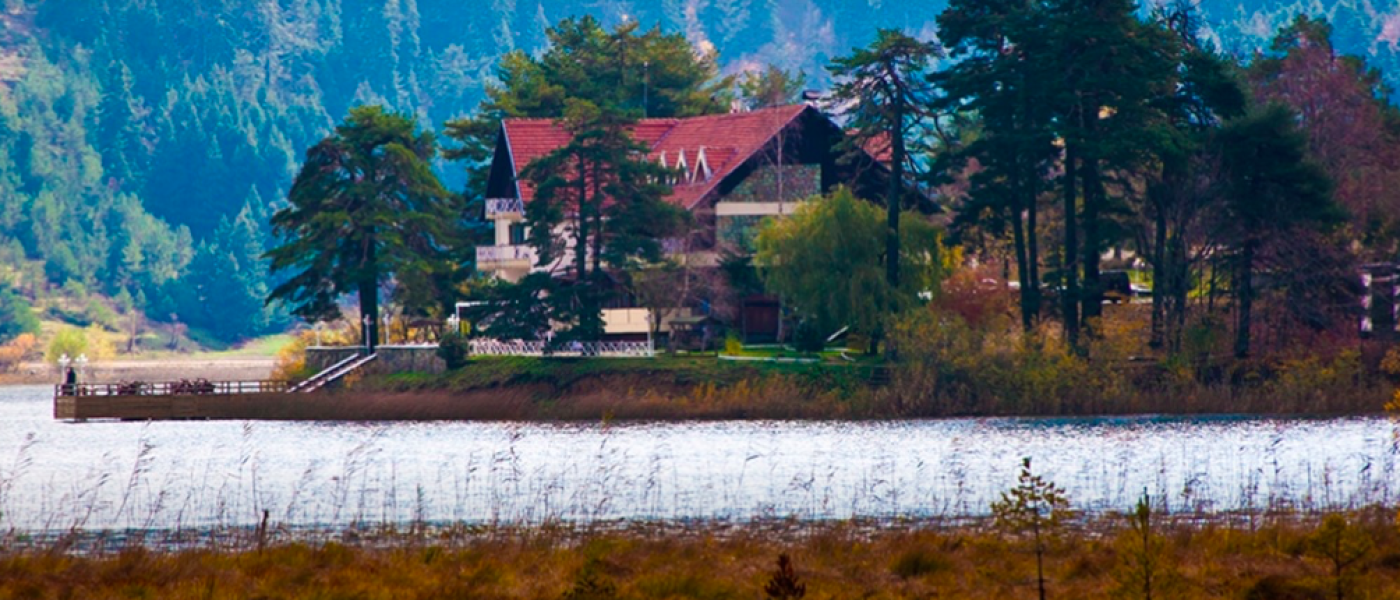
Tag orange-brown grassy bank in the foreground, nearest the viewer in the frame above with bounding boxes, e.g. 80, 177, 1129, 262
0, 510, 1400, 600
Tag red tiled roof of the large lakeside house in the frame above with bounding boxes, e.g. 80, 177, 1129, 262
503, 105, 806, 210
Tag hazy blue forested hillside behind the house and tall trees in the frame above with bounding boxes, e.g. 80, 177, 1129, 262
0, 0, 1400, 345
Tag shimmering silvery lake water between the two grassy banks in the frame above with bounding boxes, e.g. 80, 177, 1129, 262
0, 386, 1400, 531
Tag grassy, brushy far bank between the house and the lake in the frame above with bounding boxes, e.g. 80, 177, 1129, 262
337, 351, 1394, 420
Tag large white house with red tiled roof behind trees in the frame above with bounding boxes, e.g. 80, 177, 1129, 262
476, 105, 932, 337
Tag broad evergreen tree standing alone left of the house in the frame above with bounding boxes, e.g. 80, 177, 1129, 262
267, 106, 456, 345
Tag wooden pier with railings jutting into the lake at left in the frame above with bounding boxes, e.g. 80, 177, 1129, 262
53, 379, 288, 421
